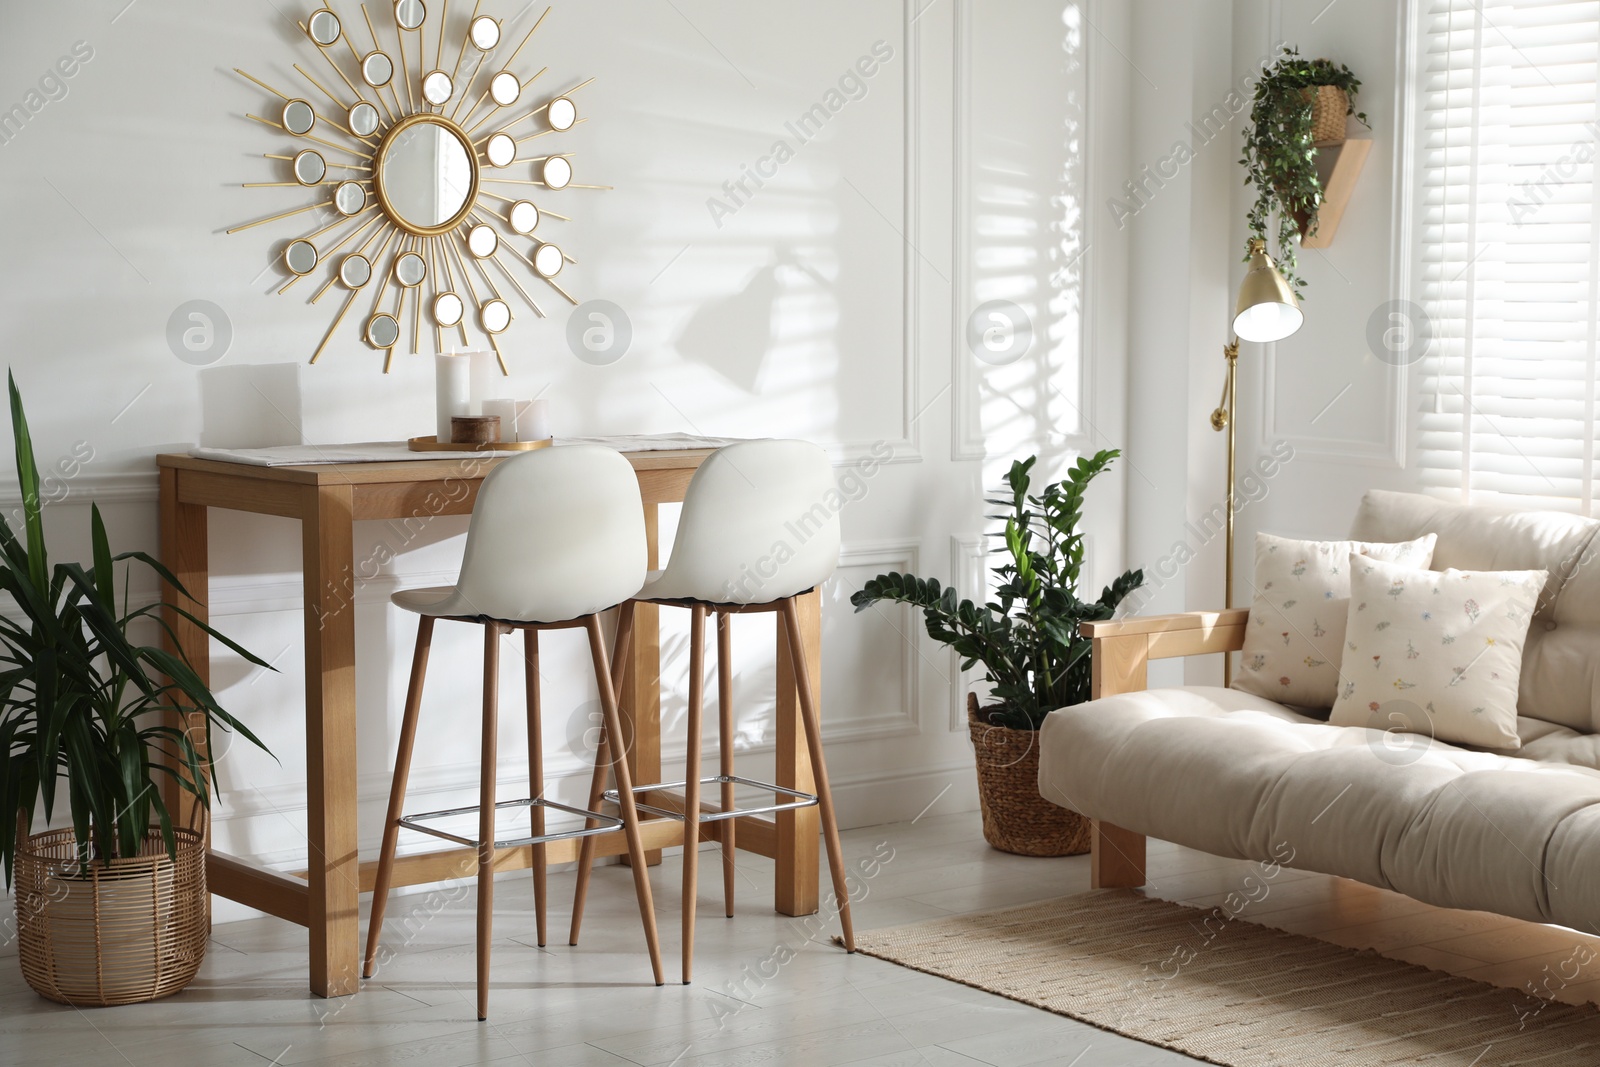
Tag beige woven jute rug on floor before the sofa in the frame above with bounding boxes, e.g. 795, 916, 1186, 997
856, 889, 1600, 1067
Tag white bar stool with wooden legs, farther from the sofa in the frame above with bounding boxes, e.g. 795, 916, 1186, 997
362, 445, 662, 1019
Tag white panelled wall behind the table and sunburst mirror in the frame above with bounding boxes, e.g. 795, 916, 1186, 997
0, 0, 1128, 921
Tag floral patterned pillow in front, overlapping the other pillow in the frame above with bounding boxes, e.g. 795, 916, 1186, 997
1328, 555, 1549, 749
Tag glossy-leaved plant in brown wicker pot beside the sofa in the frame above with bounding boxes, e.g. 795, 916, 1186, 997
850, 450, 1144, 856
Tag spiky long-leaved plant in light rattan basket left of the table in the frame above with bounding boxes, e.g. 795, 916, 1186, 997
0, 379, 267, 1006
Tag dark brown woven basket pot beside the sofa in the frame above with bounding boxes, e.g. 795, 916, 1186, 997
966, 693, 1090, 856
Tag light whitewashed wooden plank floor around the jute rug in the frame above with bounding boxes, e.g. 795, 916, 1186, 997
0, 813, 1600, 1067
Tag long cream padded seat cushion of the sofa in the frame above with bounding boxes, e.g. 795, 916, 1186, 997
1038, 686, 1600, 929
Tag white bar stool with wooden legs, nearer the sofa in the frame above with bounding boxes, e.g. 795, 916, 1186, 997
570, 440, 856, 984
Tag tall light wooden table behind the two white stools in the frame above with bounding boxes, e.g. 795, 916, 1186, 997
157, 450, 822, 997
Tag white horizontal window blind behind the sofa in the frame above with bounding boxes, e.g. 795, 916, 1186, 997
1410, 0, 1600, 515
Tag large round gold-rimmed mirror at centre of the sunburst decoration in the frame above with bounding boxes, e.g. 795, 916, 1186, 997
378, 115, 478, 234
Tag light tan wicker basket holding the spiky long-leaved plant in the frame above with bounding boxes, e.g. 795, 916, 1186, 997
16, 830, 210, 1008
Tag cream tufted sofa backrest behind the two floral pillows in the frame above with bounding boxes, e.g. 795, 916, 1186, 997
1350, 490, 1600, 733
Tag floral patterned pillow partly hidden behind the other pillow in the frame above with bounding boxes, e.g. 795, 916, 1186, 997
1234, 533, 1438, 707
